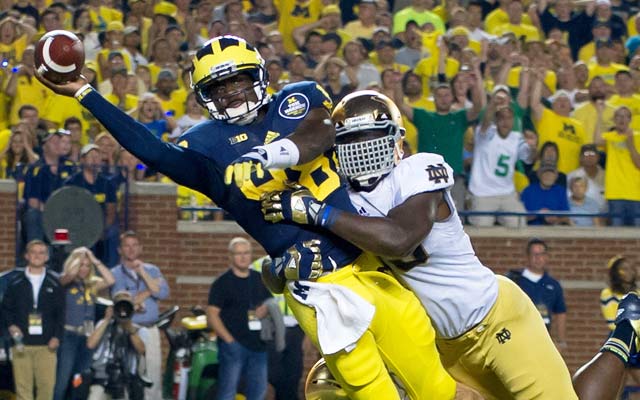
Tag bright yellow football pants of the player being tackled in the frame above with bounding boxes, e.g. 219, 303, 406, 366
285, 254, 456, 400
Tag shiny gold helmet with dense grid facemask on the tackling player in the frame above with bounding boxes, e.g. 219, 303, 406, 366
331, 90, 404, 191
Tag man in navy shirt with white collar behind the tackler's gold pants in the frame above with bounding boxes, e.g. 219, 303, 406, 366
507, 238, 567, 352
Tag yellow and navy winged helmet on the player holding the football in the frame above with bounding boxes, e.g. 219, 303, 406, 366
191, 35, 270, 125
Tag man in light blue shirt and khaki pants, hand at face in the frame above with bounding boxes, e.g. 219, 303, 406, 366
111, 231, 169, 399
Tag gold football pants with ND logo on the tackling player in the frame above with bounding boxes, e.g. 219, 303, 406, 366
437, 276, 578, 400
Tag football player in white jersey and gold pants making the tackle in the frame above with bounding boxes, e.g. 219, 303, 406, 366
263, 91, 640, 400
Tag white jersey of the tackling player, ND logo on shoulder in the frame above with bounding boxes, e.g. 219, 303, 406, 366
349, 153, 498, 338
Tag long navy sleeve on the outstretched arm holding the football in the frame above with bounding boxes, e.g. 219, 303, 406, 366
81, 90, 223, 201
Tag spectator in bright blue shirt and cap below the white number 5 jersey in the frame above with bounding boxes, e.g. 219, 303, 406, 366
521, 162, 569, 225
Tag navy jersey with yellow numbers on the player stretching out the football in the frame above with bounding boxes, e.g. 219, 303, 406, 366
81, 82, 361, 267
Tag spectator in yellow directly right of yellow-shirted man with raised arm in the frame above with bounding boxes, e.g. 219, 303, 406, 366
572, 76, 615, 138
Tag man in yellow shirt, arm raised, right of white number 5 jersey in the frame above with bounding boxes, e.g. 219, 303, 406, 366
529, 68, 589, 174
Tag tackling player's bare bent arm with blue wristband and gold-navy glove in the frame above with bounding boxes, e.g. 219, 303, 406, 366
262, 189, 442, 258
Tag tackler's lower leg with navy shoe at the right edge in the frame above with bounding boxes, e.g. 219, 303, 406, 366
573, 293, 640, 400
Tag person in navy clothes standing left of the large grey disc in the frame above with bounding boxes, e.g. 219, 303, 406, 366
24, 129, 75, 242
